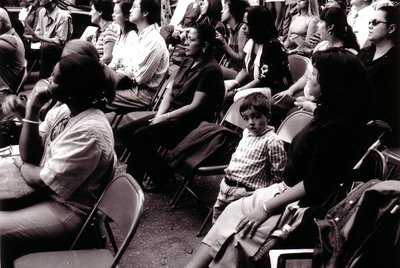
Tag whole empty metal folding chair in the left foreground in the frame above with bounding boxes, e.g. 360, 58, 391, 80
14, 173, 144, 268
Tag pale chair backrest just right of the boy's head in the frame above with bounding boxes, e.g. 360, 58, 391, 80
276, 111, 314, 144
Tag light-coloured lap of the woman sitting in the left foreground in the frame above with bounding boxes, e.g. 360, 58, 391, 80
0, 201, 85, 259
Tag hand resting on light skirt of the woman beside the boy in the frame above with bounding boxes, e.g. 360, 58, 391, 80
236, 206, 268, 238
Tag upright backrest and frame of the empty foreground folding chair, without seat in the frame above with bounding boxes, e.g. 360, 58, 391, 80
72, 173, 144, 267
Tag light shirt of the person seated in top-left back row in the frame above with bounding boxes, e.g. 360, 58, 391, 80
35, 6, 73, 45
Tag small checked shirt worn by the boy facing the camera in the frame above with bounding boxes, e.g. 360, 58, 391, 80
225, 127, 286, 189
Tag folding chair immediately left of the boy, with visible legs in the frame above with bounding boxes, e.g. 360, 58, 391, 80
170, 99, 246, 236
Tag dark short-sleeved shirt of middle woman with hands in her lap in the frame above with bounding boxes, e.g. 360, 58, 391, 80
170, 58, 225, 122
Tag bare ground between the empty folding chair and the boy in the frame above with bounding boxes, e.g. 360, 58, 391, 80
118, 162, 222, 268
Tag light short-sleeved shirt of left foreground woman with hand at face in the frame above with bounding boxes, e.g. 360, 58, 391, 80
39, 104, 114, 215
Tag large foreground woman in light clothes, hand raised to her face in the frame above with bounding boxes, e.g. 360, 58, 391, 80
0, 47, 115, 267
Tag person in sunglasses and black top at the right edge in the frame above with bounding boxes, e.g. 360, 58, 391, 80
358, 6, 400, 147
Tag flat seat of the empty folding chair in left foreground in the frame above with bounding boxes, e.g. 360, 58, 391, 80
14, 249, 114, 268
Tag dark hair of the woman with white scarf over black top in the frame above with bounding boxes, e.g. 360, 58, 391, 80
247, 6, 278, 44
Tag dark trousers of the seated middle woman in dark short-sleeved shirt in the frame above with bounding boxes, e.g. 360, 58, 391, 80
121, 119, 198, 185
